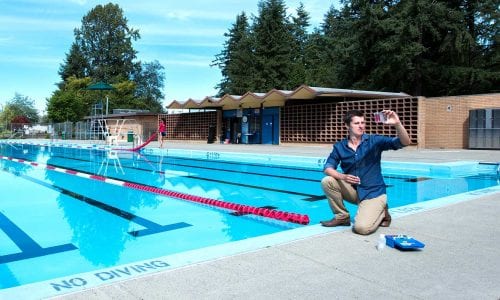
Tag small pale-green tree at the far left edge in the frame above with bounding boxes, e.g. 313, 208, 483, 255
0, 93, 39, 124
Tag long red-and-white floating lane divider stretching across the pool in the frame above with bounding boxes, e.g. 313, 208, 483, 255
0, 155, 309, 225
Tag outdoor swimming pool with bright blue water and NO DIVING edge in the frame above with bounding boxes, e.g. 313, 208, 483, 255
0, 143, 499, 298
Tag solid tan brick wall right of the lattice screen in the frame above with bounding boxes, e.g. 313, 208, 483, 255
419, 93, 500, 149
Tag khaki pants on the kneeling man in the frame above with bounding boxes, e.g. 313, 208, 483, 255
321, 176, 387, 234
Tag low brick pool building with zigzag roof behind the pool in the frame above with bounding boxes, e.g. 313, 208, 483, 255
86, 86, 500, 149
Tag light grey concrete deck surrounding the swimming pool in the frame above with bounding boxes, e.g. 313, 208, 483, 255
47, 143, 500, 300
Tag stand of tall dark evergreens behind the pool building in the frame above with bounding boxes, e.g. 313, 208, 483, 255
215, 0, 500, 96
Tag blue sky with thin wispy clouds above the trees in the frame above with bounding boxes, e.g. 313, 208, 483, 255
0, 0, 339, 114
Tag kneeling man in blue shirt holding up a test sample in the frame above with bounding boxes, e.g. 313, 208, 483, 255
321, 110, 410, 234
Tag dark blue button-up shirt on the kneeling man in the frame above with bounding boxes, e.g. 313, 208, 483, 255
323, 134, 404, 200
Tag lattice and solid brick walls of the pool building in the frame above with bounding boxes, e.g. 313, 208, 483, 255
162, 93, 500, 149
